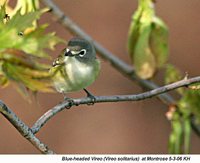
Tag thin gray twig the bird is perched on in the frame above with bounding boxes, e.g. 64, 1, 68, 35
31, 76, 200, 134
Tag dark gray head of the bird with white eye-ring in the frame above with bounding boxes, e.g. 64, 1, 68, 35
64, 38, 96, 62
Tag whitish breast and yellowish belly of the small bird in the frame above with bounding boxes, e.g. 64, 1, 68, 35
50, 57, 100, 92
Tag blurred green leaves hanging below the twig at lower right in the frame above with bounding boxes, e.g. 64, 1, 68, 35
169, 89, 200, 154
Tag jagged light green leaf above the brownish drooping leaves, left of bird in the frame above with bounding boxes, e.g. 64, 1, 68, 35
0, 7, 63, 58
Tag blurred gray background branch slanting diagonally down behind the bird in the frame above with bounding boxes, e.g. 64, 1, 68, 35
43, 0, 175, 106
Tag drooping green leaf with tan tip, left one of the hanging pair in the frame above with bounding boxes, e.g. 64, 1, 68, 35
128, 0, 156, 79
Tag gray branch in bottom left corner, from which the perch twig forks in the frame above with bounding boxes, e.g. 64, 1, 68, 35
0, 101, 54, 154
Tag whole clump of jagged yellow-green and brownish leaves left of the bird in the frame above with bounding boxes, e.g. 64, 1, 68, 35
0, 4, 64, 97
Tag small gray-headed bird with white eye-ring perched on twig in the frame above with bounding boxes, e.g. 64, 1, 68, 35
50, 38, 101, 100
